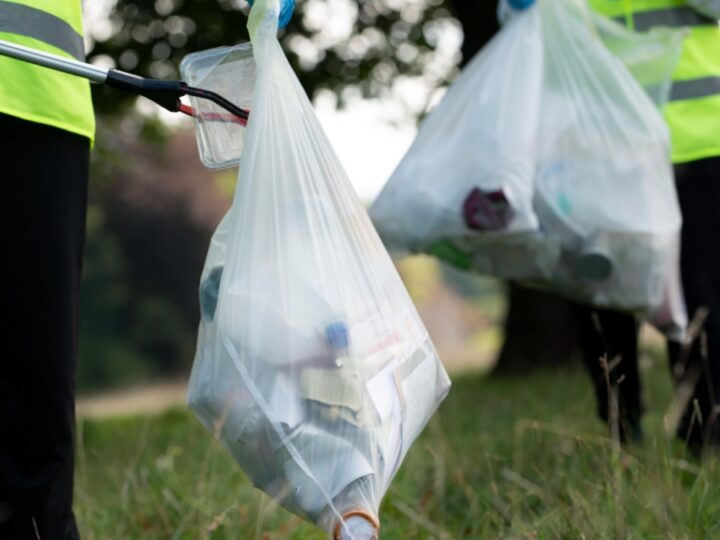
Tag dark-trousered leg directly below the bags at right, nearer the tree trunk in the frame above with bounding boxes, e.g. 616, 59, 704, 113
573, 304, 643, 441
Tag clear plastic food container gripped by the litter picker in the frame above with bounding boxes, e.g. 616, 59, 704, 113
180, 43, 255, 169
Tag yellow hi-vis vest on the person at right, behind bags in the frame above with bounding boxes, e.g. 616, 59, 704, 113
589, 0, 720, 163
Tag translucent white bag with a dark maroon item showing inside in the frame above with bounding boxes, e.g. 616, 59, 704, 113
370, 9, 543, 278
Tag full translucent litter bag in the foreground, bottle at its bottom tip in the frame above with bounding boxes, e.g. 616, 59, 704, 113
188, 0, 450, 540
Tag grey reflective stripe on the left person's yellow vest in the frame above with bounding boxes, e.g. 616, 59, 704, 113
0, 0, 85, 61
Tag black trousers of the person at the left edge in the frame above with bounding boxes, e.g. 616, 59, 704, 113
0, 115, 89, 540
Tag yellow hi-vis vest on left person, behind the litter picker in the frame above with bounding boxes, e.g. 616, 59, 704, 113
0, 0, 95, 141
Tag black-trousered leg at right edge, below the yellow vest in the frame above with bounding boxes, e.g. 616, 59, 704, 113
671, 158, 720, 450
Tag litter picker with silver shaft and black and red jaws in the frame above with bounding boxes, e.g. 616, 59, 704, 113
0, 40, 250, 125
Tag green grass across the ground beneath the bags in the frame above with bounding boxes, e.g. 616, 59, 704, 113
76, 362, 720, 539
